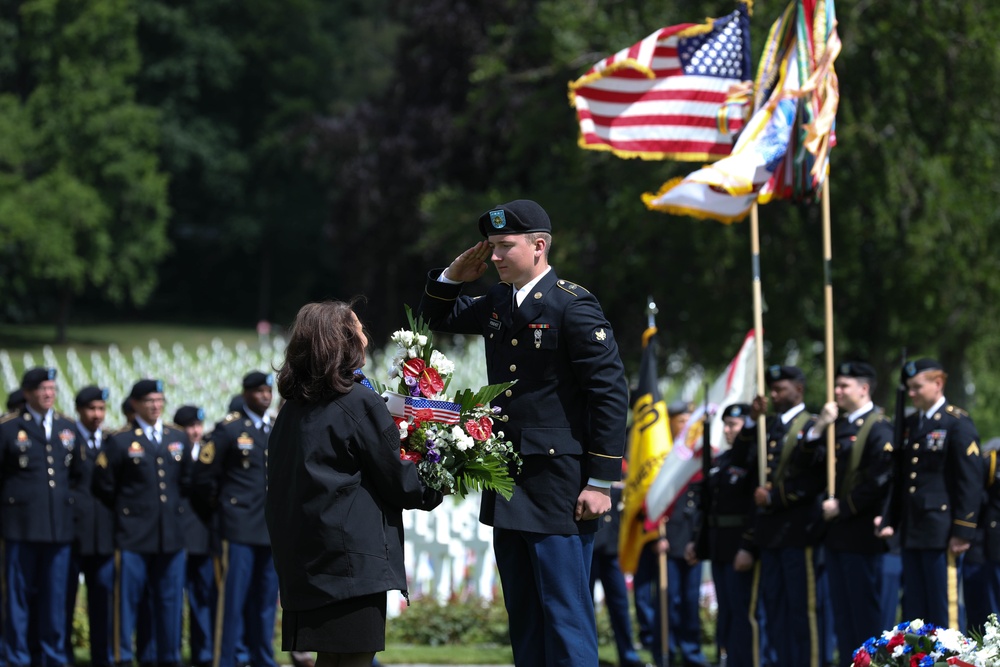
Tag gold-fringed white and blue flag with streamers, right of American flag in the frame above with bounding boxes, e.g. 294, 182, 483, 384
642, 0, 840, 223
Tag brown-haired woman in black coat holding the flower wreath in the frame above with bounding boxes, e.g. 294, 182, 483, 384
266, 301, 441, 667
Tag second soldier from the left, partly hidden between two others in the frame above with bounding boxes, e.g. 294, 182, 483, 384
66, 385, 115, 667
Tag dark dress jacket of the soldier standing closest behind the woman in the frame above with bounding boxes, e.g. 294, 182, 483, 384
192, 410, 270, 546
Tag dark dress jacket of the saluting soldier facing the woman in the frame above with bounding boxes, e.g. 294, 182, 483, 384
420, 269, 628, 535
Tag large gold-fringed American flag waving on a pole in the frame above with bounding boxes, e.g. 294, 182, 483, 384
569, 3, 751, 162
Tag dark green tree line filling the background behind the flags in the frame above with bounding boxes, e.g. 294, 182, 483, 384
0, 0, 1000, 436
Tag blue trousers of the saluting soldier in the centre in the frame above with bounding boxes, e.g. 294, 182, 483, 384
493, 528, 598, 667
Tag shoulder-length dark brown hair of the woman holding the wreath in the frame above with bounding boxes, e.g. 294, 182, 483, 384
278, 301, 365, 403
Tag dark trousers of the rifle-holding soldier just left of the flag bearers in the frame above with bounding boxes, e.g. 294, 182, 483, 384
712, 562, 759, 667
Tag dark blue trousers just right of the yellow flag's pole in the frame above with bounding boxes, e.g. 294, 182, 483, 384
653, 558, 708, 665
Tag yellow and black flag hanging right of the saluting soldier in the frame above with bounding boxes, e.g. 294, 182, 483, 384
618, 326, 673, 572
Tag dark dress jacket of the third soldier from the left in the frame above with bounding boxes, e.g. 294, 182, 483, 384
93, 422, 192, 554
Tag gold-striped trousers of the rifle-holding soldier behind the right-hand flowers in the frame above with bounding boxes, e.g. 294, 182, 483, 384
903, 549, 962, 630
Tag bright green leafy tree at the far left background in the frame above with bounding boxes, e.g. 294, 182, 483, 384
0, 0, 169, 340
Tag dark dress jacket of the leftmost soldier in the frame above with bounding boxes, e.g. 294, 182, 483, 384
0, 407, 80, 544
